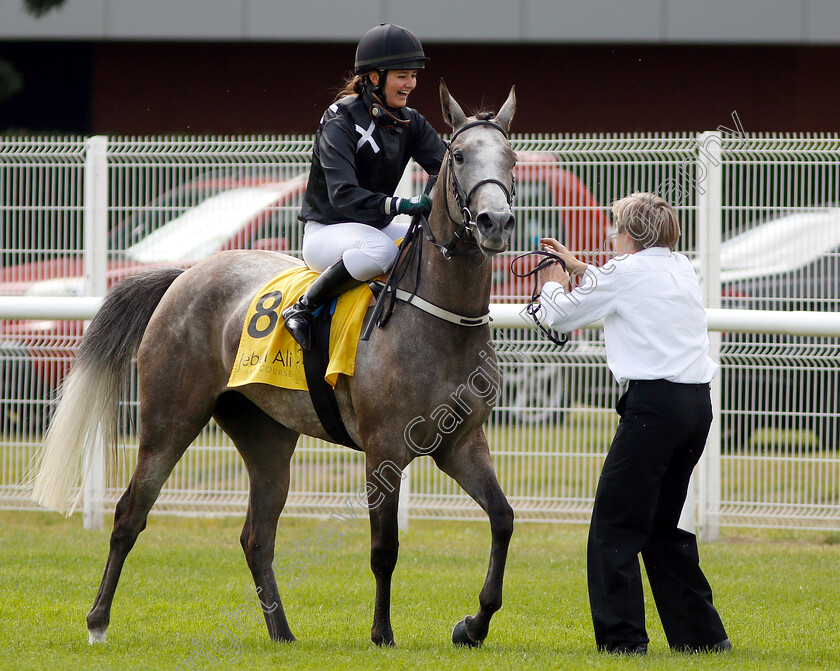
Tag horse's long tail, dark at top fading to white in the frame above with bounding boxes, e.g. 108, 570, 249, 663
32, 268, 184, 515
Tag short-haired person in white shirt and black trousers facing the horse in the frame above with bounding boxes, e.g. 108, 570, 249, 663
540, 193, 732, 654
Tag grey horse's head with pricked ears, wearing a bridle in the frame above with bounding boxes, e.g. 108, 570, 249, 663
440, 80, 516, 255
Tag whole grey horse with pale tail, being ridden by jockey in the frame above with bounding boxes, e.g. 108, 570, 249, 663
33, 82, 516, 646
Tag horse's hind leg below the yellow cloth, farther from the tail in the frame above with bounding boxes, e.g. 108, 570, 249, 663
215, 392, 299, 641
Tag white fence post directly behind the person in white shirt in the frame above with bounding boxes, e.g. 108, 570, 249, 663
695, 131, 723, 541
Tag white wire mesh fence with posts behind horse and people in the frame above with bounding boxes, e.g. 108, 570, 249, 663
0, 135, 840, 537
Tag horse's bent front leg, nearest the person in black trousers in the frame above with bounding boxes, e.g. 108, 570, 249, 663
433, 429, 513, 647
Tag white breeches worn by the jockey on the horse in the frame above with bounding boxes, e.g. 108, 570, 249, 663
303, 221, 408, 282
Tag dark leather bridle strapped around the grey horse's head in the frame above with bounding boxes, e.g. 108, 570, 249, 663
421, 119, 516, 260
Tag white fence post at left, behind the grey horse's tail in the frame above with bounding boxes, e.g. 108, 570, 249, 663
82, 135, 108, 529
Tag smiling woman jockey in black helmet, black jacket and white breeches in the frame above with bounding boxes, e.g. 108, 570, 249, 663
283, 23, 446, 350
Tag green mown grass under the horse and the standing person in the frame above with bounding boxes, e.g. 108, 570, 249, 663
0, 512, 840, 670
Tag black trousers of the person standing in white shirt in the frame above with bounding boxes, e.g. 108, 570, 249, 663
587, 380, 727, 651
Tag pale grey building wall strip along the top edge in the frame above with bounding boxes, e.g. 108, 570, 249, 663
0, 0, 840, 44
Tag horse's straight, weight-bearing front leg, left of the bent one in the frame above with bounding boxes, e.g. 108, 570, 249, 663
366, 456, 405, 645
